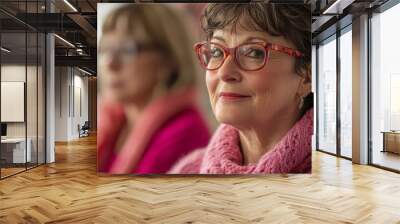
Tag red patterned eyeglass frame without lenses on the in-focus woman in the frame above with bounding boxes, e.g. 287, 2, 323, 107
193, 41, 304, 71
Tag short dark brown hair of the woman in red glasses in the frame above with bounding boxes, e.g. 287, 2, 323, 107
202, 3, 311, 77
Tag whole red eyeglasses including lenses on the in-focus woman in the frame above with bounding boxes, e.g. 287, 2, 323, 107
194, 42, 304, 71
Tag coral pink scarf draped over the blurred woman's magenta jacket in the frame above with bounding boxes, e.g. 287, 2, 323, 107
97, 88, 196, 174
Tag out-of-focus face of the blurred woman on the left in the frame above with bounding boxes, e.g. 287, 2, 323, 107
99, 21, 168, 105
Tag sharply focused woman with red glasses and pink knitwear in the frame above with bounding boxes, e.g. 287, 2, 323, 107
169, 3, 313, 174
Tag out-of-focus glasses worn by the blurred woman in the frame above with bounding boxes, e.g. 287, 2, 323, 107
98, 42, 159, 63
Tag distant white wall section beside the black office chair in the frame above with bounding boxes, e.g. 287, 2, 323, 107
55, 67, 89, 141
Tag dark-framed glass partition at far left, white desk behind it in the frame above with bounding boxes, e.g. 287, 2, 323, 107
0, 1, 46, 179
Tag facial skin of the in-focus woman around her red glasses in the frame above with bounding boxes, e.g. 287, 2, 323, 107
206, 27, 310, 128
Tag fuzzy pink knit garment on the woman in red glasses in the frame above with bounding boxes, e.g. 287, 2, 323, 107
168, 109, 313, 174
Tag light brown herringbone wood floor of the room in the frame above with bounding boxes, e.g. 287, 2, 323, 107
0, 134, 400, 224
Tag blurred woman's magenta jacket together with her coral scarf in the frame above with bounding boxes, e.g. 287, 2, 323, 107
97, 90, 210, 174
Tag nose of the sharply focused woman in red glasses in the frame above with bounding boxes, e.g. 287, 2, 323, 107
217, 55, 242, 82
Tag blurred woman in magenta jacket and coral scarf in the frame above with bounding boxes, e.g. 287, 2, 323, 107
97, 4, 210, 174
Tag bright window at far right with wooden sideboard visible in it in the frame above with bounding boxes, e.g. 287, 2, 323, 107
370, 4, 400, 170
